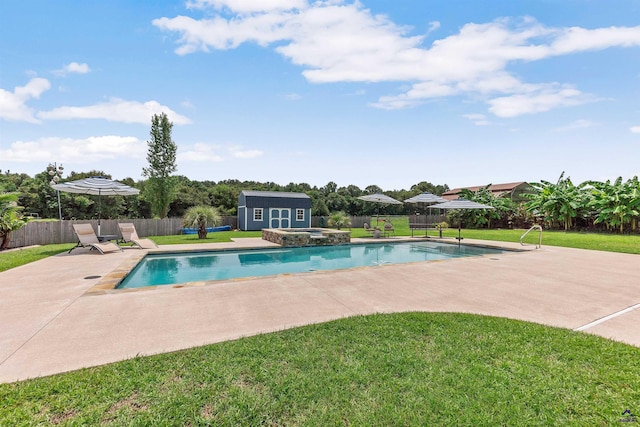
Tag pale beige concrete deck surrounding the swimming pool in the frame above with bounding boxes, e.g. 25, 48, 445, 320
0, 239, 640, 382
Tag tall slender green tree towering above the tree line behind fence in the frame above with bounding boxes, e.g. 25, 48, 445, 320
142, 113, 178, 218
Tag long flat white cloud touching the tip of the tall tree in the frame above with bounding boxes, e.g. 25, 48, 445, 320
38, 98, 191, 125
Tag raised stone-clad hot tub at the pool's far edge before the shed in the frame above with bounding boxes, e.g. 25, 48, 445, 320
262, 228, 351, 246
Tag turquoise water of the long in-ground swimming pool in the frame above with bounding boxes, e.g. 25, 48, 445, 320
118, 242, 504, 289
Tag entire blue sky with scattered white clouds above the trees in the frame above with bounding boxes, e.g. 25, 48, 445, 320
0, 0, 640, 190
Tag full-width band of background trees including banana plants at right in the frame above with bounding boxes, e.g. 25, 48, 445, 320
0, 170, 640, 233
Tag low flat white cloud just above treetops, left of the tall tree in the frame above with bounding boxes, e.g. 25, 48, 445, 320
0, 135, 147, 164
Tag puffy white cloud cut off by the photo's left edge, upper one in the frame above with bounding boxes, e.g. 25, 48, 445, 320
0, 77, 51, 123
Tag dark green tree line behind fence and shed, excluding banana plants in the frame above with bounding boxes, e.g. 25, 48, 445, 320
0, 170, 449, 219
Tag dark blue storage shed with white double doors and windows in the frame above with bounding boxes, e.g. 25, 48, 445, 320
238, 191, 311, 231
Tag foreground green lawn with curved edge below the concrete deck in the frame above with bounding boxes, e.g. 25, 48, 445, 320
0, 313, 640, 426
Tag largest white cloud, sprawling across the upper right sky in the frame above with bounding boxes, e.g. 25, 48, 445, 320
153, 0, 640, 117
